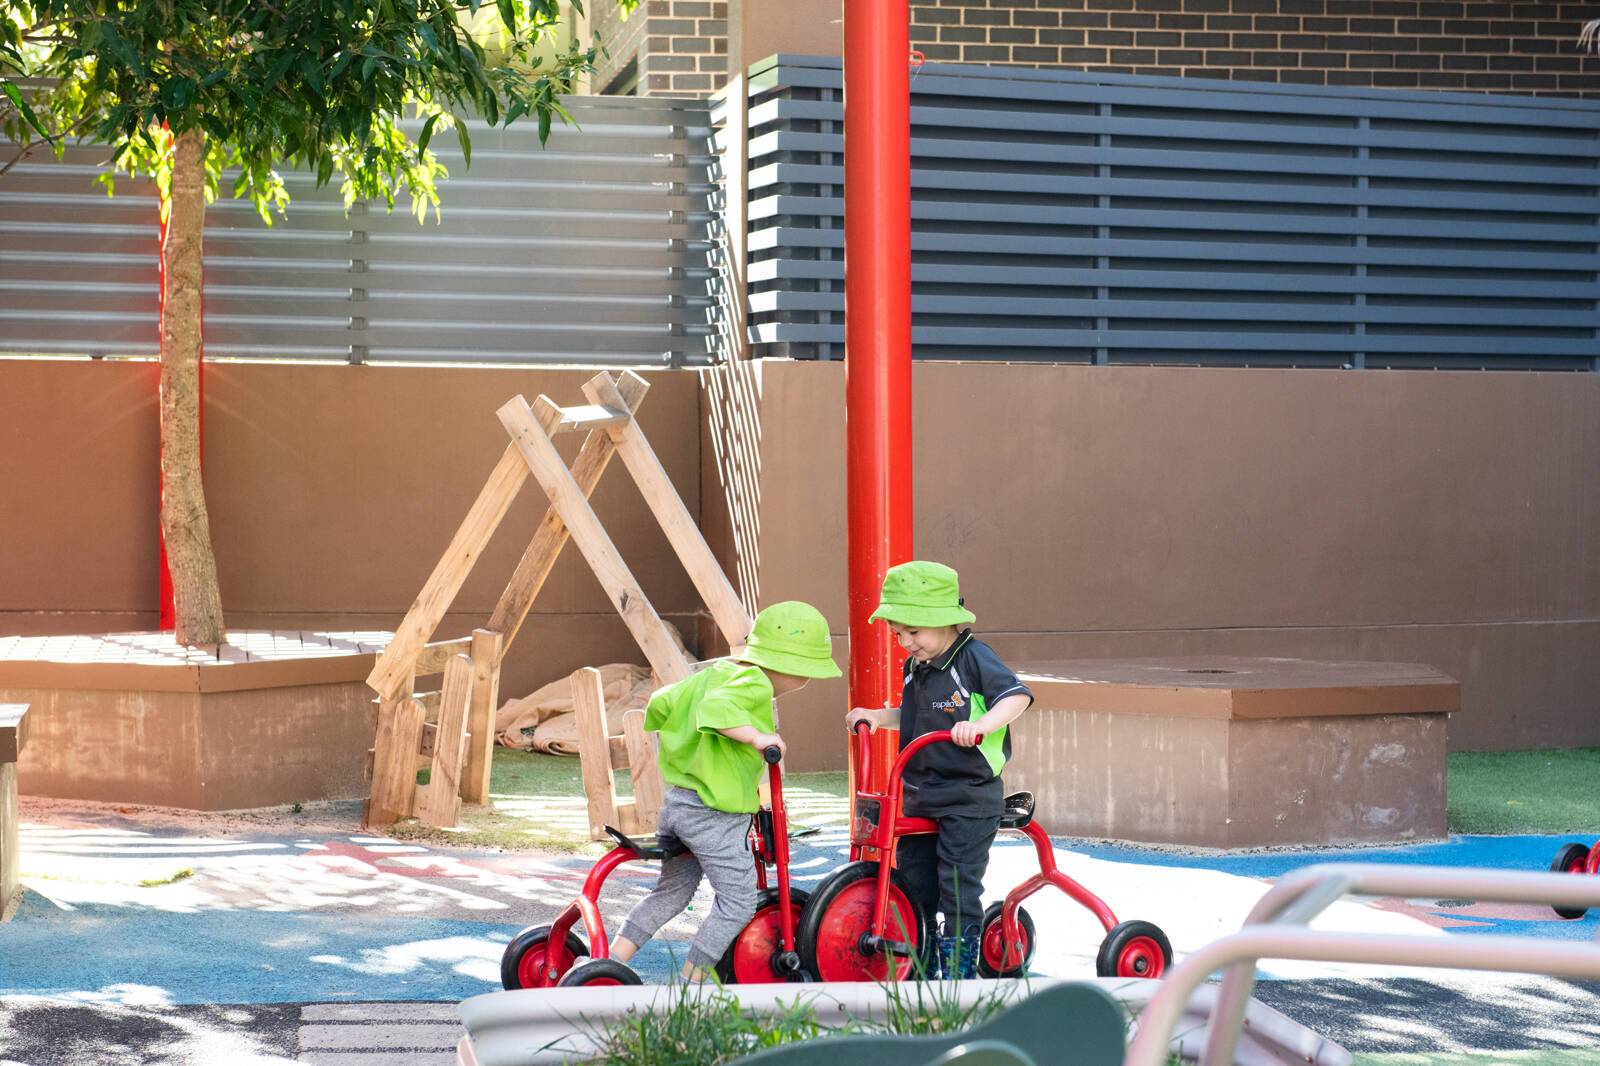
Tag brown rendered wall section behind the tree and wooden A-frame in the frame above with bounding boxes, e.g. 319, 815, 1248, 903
0, 360, 699, 696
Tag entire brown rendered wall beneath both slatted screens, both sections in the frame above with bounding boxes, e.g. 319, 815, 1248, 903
0, 360, 1600, 768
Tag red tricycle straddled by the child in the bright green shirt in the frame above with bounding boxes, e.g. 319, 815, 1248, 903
501, 746, 806, 989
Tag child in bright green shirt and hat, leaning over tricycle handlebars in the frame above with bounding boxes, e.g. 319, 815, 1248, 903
611, 600, 840, 980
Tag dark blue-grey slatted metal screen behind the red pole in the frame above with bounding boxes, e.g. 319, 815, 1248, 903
749, 56, 1600, 370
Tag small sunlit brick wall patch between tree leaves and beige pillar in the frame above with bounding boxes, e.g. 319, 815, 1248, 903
594, 0, 728, 96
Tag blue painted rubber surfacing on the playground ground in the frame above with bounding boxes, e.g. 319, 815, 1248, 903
0, 836, 1600, 1004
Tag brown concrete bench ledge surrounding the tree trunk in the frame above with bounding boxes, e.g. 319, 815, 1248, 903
0, 631, 390, 810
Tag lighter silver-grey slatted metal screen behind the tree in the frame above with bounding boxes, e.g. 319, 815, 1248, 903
0, 98, 718, 365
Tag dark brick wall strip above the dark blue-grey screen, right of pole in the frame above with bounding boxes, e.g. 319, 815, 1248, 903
910, 0, 1600, 96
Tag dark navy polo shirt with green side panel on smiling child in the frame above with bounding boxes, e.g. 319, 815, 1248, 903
901, 629, 1034, 818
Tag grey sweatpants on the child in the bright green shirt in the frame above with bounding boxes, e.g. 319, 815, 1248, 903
621, 786, 755, 970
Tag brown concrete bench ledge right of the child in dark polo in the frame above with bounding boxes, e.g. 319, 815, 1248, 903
1005, 646, 1461, 848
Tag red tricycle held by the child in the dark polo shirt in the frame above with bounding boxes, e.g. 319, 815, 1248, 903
798, 722, 1173, 981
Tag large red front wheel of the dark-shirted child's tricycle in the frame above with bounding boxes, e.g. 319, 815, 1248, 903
798, 863, 930, 981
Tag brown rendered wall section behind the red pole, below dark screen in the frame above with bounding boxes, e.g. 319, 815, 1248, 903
704, 362, 1600, 768
